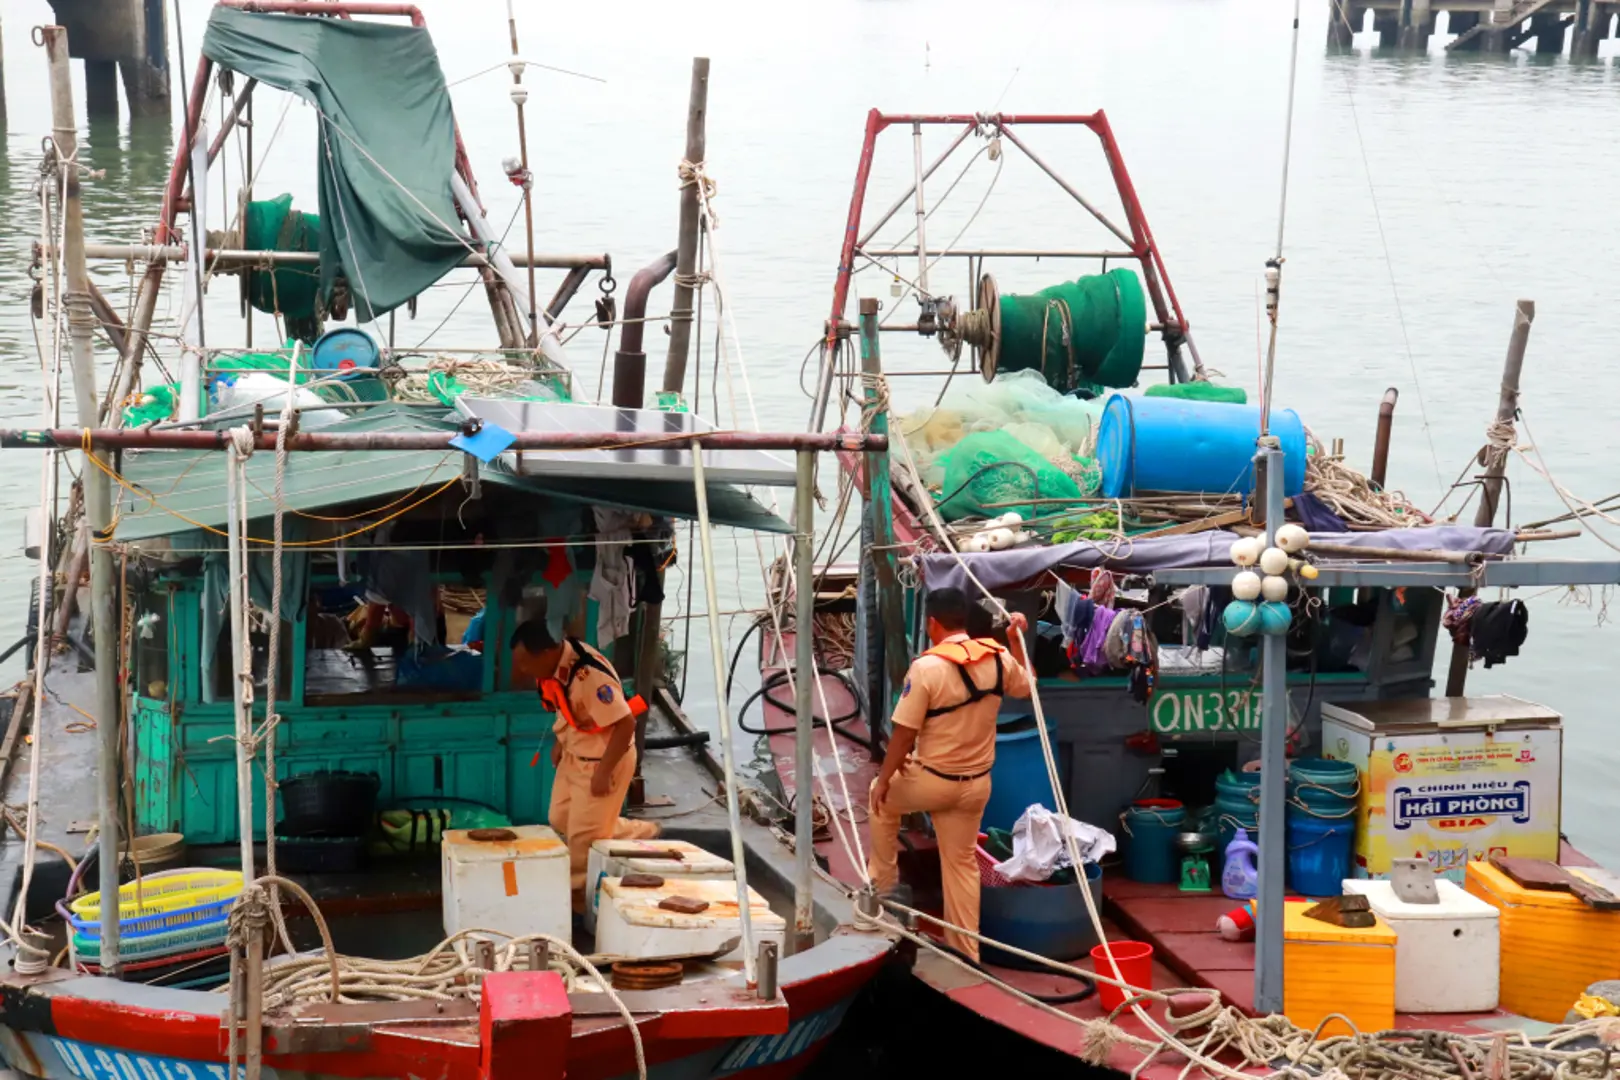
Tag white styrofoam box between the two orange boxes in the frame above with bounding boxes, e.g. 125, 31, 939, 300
1345, 879, 1502, 1012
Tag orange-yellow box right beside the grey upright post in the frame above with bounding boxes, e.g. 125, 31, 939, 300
1283, 902, 1395, 1038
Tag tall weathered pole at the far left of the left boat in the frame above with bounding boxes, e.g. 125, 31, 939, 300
42, 26, 122, 978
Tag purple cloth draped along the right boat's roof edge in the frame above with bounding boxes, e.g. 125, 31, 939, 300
917, 525, 1513, 593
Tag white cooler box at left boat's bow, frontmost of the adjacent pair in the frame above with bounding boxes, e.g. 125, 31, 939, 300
596, 878, 787, 960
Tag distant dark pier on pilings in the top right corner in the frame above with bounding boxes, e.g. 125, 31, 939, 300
1327, 0, 1620, 58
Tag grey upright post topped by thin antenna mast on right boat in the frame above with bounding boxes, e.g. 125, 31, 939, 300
1254, 0, 1299, 1014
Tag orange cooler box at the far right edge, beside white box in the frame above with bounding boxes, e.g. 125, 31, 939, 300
1468, 863, 1620, 1023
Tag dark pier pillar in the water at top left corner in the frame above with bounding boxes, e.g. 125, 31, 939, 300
29, 0, 168, 118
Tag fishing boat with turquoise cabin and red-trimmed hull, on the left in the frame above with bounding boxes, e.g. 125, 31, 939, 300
0, 0, 894, 1080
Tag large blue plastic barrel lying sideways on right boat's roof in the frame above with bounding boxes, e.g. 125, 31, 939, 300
1097, 393, 1306, 499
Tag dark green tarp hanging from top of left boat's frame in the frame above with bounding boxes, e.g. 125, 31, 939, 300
203, 6, 468, 322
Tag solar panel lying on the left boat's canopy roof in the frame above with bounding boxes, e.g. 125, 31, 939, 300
457, 395, 794, 487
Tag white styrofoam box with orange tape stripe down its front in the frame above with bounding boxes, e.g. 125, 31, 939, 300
439, 826, 573, 941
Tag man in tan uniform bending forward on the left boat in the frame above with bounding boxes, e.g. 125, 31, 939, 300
515, 620, 659, 912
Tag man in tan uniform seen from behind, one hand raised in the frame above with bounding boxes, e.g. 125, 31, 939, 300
868, 589, 1030, 960
